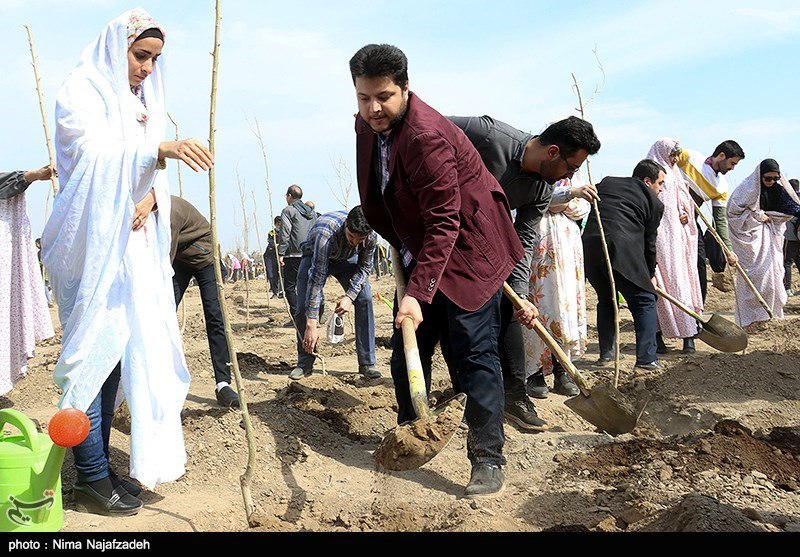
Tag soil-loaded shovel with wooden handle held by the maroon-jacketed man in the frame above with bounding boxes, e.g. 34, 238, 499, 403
375, 248, 467, 471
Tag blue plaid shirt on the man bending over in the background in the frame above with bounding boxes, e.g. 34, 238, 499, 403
302, 211, 378, 319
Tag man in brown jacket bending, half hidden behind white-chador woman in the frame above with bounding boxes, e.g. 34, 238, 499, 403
170, 195, 239, 408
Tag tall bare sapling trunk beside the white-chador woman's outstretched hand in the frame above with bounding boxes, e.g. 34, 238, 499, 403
208, 0, 256, 526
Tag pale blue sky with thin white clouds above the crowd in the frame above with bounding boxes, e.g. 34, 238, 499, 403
0, 0, 800, 250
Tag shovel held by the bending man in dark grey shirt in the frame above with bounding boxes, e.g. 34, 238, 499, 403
503, 283, 640, 435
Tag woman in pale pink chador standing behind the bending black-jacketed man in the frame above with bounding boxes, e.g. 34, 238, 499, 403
647, 137, 703, 354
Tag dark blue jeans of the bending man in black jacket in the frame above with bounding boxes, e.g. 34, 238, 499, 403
586, 267, 658, 364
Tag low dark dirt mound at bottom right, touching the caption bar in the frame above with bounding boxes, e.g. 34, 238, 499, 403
634, 494, 765, 532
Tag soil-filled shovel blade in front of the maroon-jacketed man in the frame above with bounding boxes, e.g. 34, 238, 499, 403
374, 393, 467, 472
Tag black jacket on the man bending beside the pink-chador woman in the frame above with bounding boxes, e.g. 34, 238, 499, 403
583, 176, 664, 293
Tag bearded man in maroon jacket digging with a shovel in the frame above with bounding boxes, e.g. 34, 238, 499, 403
350, 44, 533, 497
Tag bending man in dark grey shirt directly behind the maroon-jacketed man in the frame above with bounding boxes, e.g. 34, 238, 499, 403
449, 116, 600, 431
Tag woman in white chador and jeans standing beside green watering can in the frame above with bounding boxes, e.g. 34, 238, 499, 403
42, 8, 212, 515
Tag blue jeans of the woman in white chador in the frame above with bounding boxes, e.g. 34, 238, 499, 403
72, 364, 120, 483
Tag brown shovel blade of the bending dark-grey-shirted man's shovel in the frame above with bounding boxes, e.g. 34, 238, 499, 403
564, 382, 639, 435
